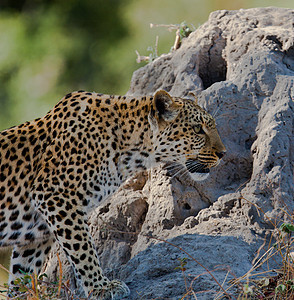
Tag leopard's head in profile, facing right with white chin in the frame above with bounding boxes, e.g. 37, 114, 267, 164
148, 91, 226, 181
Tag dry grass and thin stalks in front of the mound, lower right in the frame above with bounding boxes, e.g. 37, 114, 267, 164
169, 217, 294, 300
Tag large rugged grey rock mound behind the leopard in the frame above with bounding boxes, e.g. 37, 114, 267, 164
46, 7, 294, 299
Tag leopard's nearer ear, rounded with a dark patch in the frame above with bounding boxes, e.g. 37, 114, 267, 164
154, 90, 181, 122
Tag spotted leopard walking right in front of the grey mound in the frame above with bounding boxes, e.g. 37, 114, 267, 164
0, 90, 226, 299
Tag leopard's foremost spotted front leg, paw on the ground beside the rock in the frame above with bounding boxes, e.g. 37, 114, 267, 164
35, 193, 129, 299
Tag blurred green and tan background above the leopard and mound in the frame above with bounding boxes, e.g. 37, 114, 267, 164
0, 0, 294, 290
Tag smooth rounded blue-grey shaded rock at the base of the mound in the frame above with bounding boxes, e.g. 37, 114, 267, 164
120, 234, 254, 299
